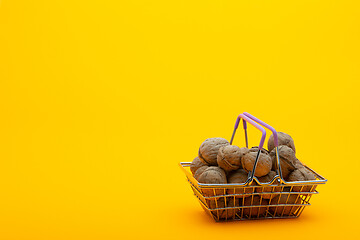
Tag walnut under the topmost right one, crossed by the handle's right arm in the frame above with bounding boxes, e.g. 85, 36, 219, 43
270, 145, 299, 179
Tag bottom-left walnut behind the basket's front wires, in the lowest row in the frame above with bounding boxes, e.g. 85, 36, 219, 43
207, 197, 239, 219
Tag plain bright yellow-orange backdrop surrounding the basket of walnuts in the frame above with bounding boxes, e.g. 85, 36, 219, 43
0, 0, 360, 240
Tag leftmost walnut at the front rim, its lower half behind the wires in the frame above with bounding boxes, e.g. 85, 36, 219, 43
198, 167, 227, 197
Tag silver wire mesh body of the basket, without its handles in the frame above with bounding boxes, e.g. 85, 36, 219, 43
180, 162, 326, 221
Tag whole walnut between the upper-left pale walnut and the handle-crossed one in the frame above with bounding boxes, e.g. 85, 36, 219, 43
217, 145, 244, 171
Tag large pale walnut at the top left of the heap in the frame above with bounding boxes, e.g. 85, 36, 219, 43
199, 138, 229, 166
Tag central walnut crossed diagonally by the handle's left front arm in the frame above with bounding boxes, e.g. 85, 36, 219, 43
241, 151, 272, 177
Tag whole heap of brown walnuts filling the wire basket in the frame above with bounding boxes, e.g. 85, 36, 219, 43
190, 132, 316, 219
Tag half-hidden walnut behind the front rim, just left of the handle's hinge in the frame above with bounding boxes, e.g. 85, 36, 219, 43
226, 169, 256, 198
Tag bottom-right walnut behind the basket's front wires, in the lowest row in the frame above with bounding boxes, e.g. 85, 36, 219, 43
269, 194, 301, 216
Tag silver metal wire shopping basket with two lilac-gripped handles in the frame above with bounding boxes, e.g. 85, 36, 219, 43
179, 113, 327, 221
